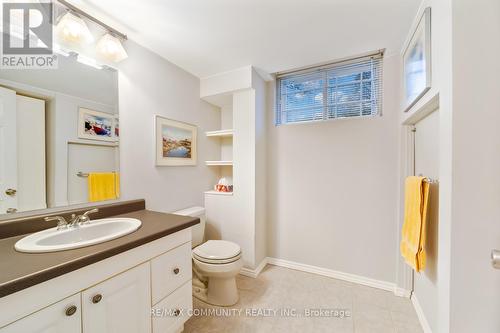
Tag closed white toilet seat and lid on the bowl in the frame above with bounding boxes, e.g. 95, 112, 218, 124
193, 240, 241, 264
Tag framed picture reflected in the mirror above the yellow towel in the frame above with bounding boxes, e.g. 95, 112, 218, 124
78, 108, 116, 141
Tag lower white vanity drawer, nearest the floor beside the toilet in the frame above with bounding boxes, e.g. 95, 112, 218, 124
151, 280, 193, 333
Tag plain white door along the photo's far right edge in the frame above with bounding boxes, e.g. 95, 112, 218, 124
450, 0, 500, 333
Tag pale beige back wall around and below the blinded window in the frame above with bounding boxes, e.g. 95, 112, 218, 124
267, 56, 399, 282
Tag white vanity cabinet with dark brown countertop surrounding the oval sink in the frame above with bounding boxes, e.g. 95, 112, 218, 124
0, 200, 199, 333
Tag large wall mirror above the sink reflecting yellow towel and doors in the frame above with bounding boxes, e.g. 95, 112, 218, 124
0, 56, 120, 214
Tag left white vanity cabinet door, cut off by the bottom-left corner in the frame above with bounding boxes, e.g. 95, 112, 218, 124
0, 294, 82, 333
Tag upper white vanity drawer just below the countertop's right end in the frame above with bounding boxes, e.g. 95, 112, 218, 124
151, 242, 192, 305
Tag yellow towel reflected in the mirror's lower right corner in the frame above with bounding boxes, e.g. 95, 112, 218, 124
88, 172, 120, 202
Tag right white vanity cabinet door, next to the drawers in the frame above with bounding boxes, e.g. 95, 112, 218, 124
82, 262, 151, 333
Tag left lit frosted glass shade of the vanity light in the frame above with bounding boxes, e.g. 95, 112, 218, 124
56, 12, 94, 44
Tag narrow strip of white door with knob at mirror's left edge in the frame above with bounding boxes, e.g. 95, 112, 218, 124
0, 87, 18, 214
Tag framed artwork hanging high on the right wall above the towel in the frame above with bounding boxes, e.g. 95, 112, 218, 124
403, 7, 431, 112
